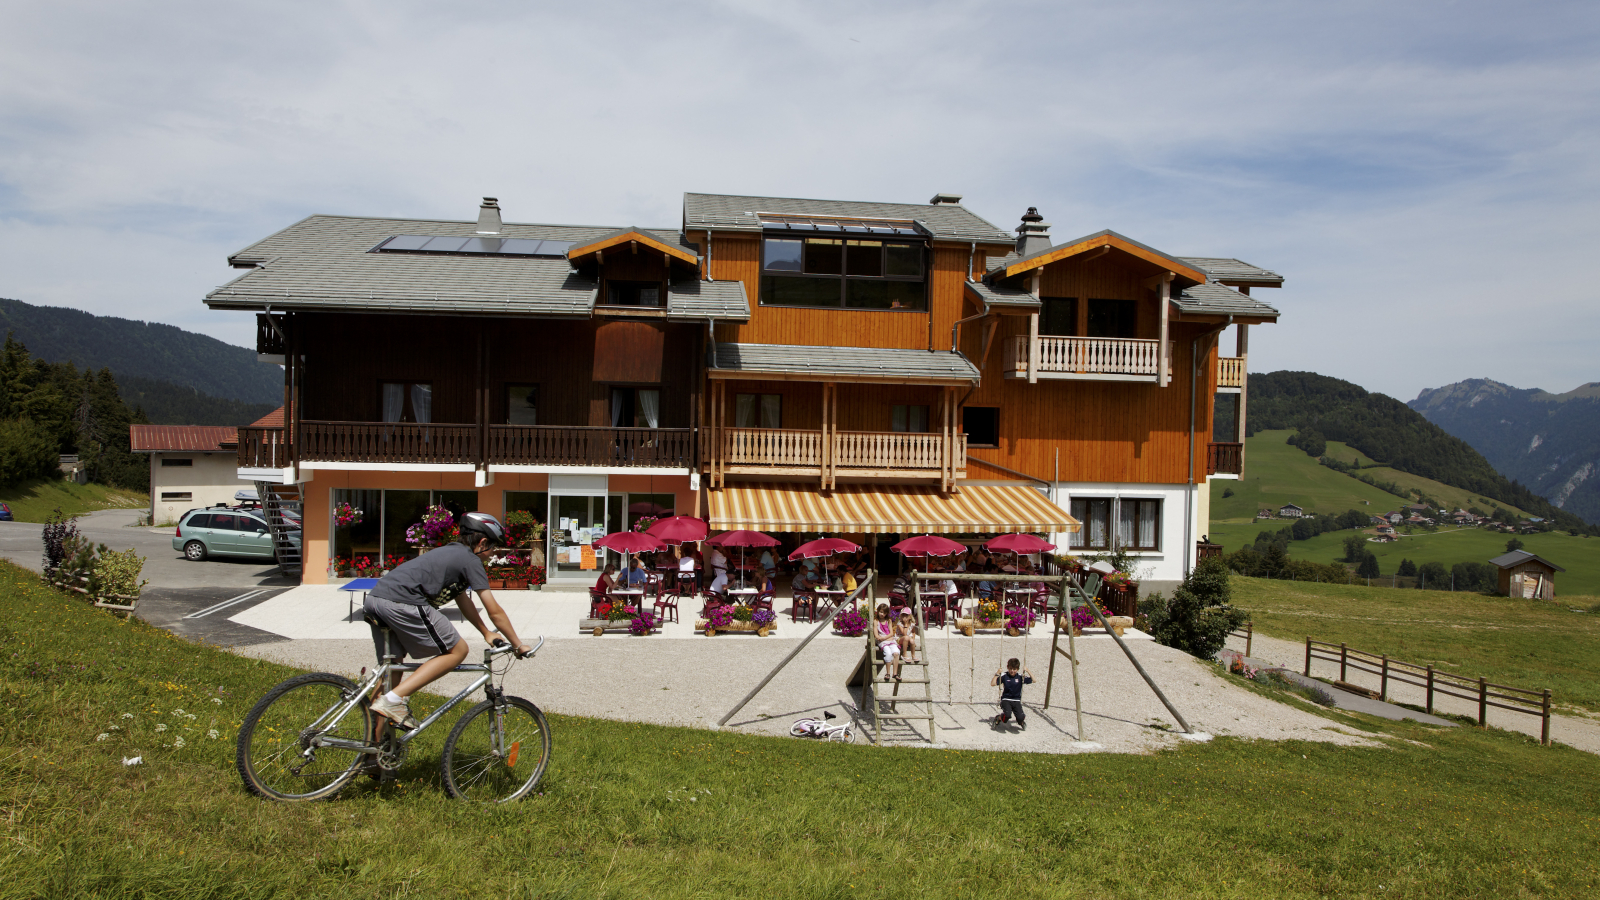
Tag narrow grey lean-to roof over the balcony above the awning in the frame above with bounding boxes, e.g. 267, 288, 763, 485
715, 344, 978, 383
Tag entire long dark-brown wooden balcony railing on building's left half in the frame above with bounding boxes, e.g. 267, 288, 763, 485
238, 421, 691, 469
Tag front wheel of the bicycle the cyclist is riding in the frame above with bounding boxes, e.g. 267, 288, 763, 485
438, 697, 550, 802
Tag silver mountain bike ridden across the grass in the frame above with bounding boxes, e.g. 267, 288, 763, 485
235, 613, 550, 802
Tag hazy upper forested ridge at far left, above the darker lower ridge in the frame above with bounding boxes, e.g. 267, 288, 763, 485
0, 298, 283, 400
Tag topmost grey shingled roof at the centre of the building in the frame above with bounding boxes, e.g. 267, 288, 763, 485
683, 194, 1014, 243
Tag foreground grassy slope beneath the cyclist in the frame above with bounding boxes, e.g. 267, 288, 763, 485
0, 565, 1600, 900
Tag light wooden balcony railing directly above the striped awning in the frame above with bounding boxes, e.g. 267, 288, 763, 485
709, 428, 966, 480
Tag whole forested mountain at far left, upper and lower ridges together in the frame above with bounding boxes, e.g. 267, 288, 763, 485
0, 298, 283, 424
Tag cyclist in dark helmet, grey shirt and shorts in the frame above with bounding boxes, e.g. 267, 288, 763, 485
365, 512, 528, 730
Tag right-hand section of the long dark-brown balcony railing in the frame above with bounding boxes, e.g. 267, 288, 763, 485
486, 424, 693, 468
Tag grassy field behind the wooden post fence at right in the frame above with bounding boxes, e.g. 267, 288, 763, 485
1232, 577, 1600, 711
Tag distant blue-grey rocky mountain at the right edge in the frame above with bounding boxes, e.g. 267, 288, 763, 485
1408, 378, 1600, 522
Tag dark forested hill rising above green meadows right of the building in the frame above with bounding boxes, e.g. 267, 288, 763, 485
1246, 372, 1587, 528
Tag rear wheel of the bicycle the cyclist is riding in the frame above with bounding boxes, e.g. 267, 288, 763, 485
234, 673, 371, 801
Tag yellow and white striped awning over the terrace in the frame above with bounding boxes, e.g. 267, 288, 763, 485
707, 482, 1082, 535
